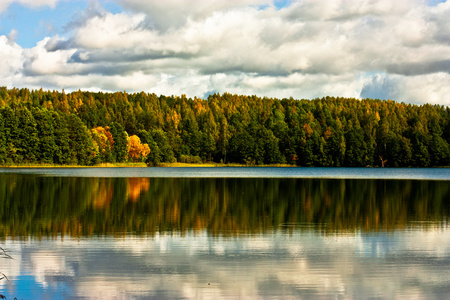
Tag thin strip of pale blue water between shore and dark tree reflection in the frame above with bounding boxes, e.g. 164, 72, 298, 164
0, 167, 450, 180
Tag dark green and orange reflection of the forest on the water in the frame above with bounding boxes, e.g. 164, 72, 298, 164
0, 174, 450, 236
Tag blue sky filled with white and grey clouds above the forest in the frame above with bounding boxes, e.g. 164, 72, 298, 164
0, 0, 450, 106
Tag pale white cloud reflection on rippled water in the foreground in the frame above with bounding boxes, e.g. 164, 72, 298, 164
1, 226, 450, 299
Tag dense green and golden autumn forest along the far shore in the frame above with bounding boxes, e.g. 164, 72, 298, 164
0, 87, 450, 167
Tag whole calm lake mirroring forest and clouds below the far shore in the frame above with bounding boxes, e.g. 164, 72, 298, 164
0, 167, 450, 299
